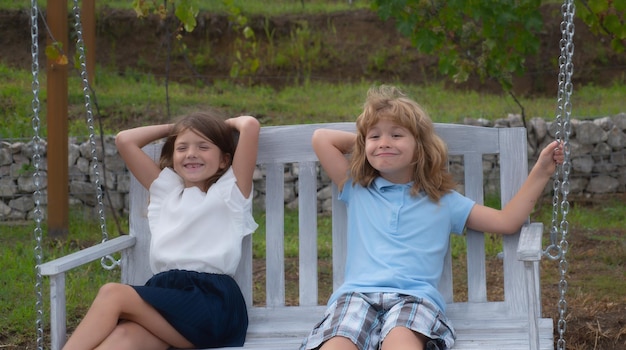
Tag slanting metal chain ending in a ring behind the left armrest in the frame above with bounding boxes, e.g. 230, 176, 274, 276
73, 0, 120, 270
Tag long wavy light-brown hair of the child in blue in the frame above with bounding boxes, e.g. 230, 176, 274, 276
350, 85, 456, 201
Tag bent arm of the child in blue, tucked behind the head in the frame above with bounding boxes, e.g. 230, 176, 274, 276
311, 129, 356, 190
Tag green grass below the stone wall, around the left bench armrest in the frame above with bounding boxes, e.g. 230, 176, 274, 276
0, 208, 122, 348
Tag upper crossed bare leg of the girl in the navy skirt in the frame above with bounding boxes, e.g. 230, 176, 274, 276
63, 283, 193, 350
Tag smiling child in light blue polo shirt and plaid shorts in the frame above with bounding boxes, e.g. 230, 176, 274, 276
301, 86, 563, 350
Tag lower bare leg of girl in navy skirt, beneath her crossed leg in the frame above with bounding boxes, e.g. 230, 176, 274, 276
96, 321, 170, 350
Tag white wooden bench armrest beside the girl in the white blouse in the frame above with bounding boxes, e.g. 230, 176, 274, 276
39, 236, 135, 276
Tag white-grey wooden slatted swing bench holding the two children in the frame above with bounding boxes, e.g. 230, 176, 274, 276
40, 123, 553, 350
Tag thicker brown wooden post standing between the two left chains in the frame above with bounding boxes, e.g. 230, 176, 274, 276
46, 0, 69, 238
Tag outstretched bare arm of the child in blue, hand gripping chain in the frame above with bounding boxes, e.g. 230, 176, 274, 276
467, 141, 564, 234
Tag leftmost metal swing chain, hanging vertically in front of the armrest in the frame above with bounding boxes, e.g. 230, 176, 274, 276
30, 0, 44, 350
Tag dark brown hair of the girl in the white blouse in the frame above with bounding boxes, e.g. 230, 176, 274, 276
159, 110, 236, 188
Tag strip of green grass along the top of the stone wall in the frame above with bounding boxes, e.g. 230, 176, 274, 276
0, 63, 626, 139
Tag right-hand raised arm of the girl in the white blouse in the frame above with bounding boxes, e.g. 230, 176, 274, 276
226, 116, 261, 198
